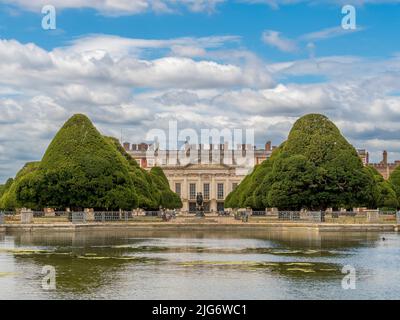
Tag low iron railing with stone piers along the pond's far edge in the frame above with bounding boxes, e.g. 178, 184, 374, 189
0, 209, 400, 224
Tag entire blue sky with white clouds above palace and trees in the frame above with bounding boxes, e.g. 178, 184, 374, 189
0, 0, 400, 183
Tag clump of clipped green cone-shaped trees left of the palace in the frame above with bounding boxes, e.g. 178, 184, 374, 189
0, 114, 179, 210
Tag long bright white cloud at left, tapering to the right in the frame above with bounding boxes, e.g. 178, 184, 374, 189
0, 36, 272, 94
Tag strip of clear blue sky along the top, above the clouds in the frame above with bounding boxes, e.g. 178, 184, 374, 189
0, 1, 400, 61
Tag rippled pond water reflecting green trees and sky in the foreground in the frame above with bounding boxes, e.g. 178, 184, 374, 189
0, 230, 400, 299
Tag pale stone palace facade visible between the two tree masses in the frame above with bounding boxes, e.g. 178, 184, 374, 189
123, 141, 275, 212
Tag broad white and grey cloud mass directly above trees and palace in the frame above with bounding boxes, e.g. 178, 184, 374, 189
0, 35, 400, 181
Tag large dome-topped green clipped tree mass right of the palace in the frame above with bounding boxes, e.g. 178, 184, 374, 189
228, 114, 376, 210
